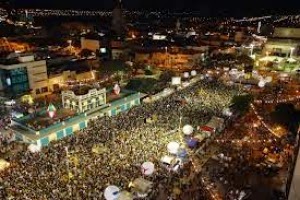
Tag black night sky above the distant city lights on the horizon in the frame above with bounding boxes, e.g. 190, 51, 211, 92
12, 0, 300, 16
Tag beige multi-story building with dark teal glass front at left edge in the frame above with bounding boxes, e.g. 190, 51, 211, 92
0, 55, 48, 97
